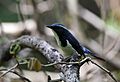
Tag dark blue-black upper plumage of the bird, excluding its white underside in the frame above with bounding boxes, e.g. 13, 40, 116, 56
47, 24, 103, 60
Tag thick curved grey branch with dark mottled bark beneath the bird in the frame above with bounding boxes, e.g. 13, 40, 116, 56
13, 35, 80, 82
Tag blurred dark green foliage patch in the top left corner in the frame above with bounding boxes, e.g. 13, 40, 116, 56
0, 0, 18, 22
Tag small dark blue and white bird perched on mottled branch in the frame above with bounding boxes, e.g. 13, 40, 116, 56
46, 23, 104, 60
